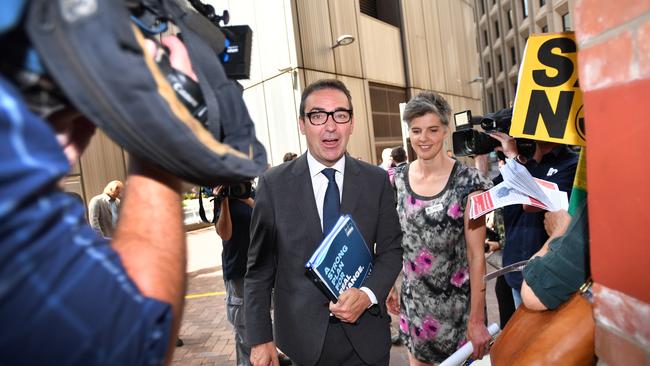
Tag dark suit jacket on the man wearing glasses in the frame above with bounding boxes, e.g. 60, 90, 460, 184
244, 154, 402, 365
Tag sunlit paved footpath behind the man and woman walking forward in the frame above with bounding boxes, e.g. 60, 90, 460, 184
172, 227, 499, 366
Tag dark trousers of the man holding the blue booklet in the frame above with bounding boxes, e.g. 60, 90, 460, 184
316, 321, 390, 366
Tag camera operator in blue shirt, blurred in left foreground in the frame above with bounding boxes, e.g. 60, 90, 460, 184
0, 1, 204, 365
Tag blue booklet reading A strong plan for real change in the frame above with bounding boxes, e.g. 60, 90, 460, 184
305, 215, 372, 302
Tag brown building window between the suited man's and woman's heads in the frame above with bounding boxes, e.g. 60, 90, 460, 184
369, 83, 407, 163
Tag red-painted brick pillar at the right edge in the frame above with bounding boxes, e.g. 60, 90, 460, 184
574, 0, 650, 365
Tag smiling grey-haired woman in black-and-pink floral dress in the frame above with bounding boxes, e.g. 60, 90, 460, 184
386, 92, 491, 366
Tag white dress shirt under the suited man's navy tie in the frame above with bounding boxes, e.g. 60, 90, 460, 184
307, 150, 377, 305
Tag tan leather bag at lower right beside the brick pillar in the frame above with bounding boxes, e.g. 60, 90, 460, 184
490, 293, 596, 366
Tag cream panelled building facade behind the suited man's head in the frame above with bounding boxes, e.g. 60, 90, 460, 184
66, 0, 483, 200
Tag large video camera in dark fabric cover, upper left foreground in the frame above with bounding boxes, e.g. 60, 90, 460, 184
6, 0, 267, 186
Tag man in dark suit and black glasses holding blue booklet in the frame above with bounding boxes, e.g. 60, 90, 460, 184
245, 80, 402, 366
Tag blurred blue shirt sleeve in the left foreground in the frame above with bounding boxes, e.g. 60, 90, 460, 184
0, 77, 172, 365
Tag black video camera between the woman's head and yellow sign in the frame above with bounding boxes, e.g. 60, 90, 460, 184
451, 108, 536, 158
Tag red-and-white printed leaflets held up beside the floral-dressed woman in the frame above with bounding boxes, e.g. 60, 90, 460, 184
470, 159, 569, 219
